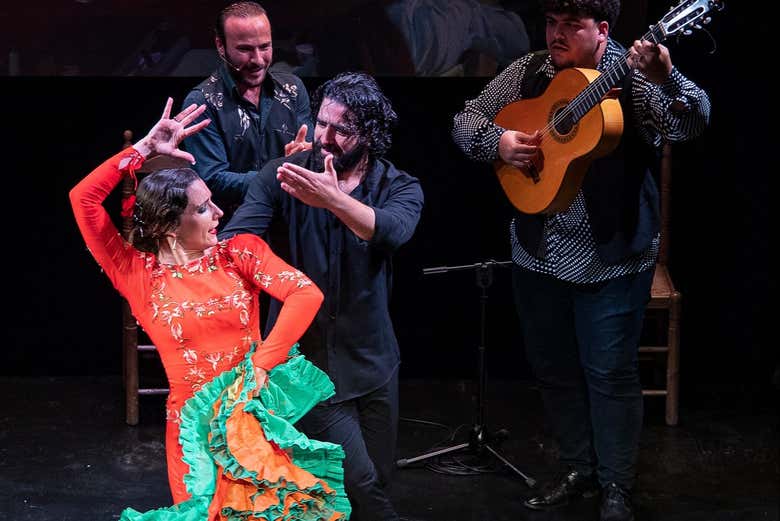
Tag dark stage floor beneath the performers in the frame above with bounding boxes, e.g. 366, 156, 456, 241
0, 377, 780, 521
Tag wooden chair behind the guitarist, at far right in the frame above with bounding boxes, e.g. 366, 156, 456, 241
639, 144, 682, 425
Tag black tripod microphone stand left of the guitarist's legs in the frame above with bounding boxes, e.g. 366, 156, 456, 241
396, 260, 536, 488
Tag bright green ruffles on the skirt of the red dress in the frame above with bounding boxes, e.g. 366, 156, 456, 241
120, 344, 351, 521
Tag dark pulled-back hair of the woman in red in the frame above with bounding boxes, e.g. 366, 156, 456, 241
129, 168, 199, 255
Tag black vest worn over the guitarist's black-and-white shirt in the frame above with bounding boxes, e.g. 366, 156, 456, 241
515, 51, 661, 265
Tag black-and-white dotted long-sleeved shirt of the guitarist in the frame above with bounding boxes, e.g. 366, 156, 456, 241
452, 39, 710, 283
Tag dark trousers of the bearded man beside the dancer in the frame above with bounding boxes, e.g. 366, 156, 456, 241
297, 369, 398, 521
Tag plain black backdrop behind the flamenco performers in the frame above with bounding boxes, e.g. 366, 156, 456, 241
0, 0, 777, 407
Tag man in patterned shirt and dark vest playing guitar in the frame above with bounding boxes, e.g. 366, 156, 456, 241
452, 0, 710, 521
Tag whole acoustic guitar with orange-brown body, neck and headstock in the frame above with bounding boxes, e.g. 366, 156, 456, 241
494, 0, 723, 214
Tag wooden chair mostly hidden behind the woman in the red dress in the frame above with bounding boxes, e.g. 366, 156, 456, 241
122, 130, 189, 425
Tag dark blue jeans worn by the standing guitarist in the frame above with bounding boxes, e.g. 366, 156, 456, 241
512, 266, 653, 490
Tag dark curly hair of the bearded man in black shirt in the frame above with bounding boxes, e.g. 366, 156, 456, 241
311, 72, 398, 160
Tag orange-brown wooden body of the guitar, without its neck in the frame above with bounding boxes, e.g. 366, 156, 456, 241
495, 68, 623, 214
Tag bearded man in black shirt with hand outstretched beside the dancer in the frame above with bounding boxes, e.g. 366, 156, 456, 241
220, 73, 423, 521
